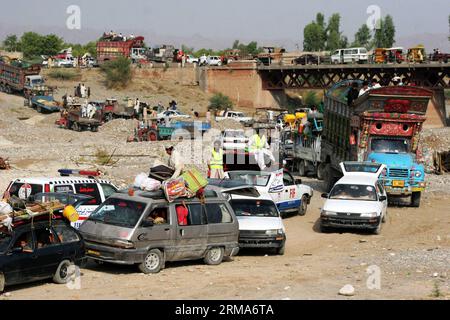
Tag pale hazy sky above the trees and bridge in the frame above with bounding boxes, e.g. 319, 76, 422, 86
0, 0, 450, 46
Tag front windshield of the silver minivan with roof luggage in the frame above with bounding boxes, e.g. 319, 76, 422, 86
89, 198, 146, 228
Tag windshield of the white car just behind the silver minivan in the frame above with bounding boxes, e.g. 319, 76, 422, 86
230, 199, 279, 217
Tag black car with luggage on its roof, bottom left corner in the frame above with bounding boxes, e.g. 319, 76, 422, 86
0, 217, 84, 293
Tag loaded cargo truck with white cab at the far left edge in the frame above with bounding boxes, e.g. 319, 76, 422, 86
0, 57, 50, 99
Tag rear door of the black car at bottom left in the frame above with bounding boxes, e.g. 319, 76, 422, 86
33, 226, 64, 278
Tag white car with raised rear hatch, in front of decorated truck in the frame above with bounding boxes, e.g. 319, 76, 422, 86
320, 162, 387, 234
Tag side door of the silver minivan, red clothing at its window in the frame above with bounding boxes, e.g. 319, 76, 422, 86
172, 203, 208, 260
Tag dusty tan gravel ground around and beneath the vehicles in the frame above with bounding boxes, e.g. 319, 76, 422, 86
0, 72, 450, 299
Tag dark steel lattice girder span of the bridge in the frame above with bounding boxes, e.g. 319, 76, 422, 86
255, 63, 450, 90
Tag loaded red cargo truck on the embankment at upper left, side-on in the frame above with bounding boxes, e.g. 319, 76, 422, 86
97, 37, 146, 65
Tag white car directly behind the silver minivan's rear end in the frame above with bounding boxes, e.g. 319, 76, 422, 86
230, 195, 286, 255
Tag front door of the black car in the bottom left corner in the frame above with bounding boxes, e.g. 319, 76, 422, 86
2, 229, 35, 284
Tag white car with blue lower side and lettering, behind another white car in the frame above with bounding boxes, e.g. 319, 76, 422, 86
226, 170, 313, 216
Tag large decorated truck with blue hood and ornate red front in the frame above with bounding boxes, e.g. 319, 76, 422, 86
320, 80, 432, 207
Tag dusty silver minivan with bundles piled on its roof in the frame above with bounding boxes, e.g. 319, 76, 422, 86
80, 190, 239, 273
